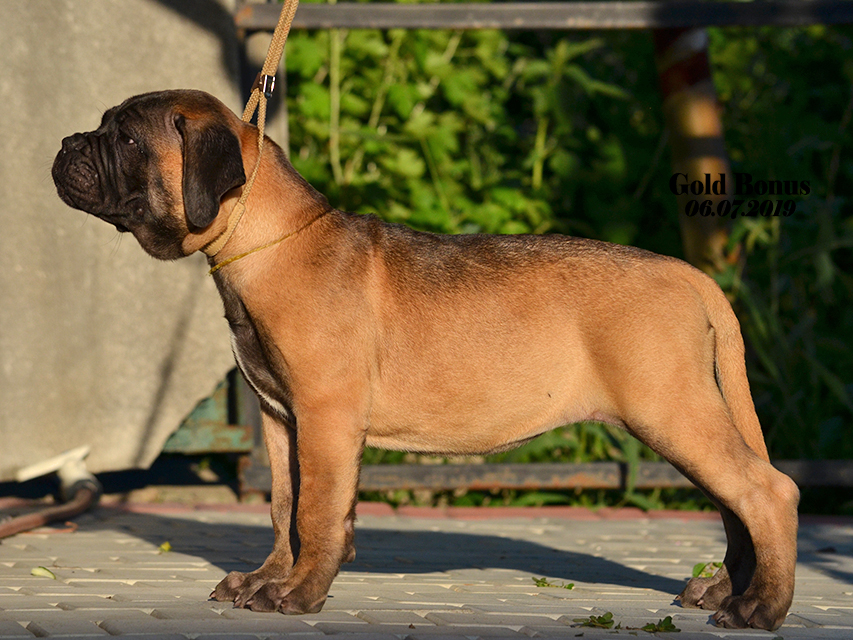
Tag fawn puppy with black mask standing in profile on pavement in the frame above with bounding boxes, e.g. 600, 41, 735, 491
53, 91, 799, 629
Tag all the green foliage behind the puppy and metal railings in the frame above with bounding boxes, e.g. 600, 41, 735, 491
287, 3, 853, 509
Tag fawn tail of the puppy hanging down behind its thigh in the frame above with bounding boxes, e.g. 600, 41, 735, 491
691, 269, 770, 461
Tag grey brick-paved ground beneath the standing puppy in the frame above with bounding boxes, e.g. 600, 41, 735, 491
0, 506, 853, 640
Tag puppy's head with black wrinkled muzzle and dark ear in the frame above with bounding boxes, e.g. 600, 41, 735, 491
52, 91, 246, 260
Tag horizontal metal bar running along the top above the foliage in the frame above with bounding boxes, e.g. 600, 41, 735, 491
234, 0, 853, 31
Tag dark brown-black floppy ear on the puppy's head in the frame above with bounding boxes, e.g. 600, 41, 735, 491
175, 115, 246, 229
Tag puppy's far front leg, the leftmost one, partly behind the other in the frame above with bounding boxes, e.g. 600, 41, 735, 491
210, 411, 299, 611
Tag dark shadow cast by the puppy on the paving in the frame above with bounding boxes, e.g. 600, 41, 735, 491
80, 509, 688, 596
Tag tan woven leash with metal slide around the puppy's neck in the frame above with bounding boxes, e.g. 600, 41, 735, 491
204, 0, 299, 258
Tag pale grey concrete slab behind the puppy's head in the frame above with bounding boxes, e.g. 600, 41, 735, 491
0, 0, 242, 480
